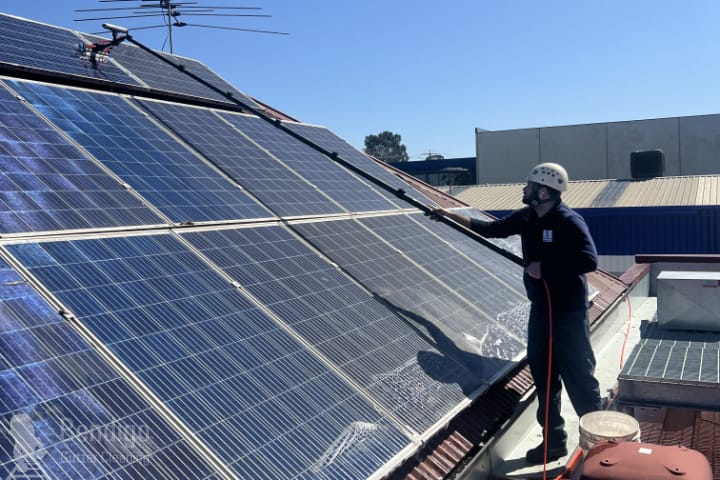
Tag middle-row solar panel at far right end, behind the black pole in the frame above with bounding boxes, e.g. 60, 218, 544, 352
283, 122, 435, 206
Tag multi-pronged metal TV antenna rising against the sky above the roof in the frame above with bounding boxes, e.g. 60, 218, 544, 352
75, 0, 287, 53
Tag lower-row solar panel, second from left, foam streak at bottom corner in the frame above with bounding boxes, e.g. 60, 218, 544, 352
7, 234, 409, 479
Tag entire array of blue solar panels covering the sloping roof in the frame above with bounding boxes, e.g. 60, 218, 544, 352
0, 11, 527, 479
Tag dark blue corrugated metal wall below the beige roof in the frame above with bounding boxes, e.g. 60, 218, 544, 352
489, 206, 720, 255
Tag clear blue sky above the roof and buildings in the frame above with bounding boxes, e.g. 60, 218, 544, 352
0, 0, 720, 160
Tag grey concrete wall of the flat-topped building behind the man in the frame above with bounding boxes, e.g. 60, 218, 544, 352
475, 114, 720, 184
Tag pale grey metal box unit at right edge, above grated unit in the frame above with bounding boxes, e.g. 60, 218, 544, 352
657, 271, 720, 332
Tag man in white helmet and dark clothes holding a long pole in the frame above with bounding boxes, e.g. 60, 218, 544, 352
432, 163, 601, 465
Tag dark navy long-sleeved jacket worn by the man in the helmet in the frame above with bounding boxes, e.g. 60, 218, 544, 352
470, 202, 597, 311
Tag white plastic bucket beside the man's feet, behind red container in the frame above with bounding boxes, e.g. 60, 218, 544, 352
579, 410, 640, 454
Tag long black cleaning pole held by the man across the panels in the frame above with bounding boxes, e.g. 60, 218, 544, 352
125, 33, 524, 266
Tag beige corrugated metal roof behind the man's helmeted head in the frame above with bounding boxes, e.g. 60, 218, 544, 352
455, 175, 720, 210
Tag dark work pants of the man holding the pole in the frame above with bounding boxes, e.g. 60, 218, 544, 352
527, 303, 601, 445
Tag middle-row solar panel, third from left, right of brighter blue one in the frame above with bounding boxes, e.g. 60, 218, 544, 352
140, 100, 344, 217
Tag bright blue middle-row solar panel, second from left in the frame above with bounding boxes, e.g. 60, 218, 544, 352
10, 81, 272, 223
